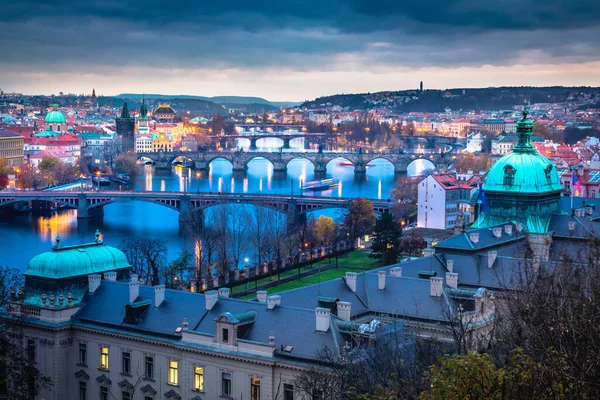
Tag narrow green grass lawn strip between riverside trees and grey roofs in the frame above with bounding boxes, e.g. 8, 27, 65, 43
231, 250, 380, 299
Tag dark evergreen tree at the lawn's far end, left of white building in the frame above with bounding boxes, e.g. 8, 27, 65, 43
369, 211, 402, 265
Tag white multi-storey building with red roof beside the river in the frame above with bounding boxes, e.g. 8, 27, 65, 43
417, 171, 481, 229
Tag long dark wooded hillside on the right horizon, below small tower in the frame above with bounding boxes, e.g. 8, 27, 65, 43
301, 86, 599, 112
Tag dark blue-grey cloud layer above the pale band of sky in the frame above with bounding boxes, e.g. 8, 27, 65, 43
0, 0, 600, 90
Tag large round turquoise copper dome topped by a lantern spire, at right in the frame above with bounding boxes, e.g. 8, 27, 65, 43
483, 109, 562, 194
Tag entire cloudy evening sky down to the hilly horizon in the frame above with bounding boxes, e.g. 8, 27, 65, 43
0, 0, 600, 101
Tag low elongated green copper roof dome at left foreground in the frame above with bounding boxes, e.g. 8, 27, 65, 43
23, 242, 131, 279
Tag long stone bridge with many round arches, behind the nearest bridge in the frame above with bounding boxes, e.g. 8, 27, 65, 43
138, 151, 452, 176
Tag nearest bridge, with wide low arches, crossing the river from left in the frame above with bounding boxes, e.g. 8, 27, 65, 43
0, 191, 392, 225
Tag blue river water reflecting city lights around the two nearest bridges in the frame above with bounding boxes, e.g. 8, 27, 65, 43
0, 150, 430, 271
